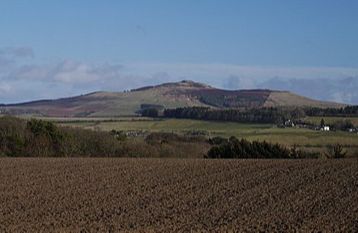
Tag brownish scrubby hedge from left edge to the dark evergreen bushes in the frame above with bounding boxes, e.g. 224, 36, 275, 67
0, 117, 210, 157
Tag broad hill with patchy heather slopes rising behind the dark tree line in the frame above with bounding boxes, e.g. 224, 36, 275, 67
0, 80, 344, 117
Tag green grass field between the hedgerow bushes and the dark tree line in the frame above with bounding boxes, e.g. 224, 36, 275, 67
55, 118, 358, 154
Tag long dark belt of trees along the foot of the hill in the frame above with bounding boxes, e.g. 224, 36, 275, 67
142, 106, 358, 125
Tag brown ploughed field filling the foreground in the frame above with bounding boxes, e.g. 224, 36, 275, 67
0, 158, 358, 232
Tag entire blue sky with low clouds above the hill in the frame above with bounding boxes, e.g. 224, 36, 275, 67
0, 0, 358, 104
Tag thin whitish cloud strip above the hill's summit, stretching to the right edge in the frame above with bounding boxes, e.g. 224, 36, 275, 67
122, 63, 358, 79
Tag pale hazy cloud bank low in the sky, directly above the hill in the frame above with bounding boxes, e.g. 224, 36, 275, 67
0, 48, 358, 104
